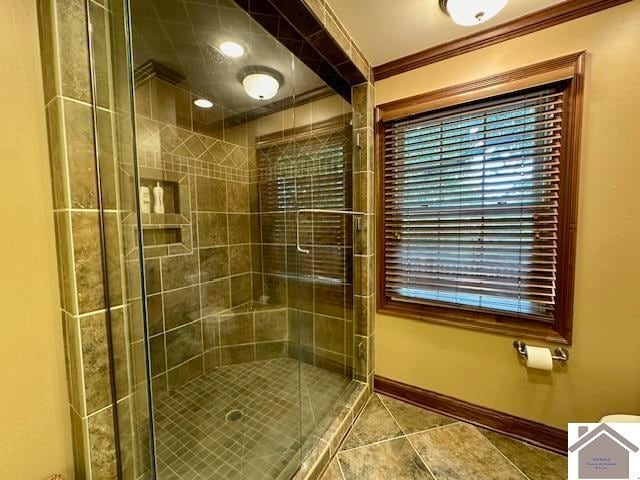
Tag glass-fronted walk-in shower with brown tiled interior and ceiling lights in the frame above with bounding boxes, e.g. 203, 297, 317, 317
77, 0, 366, 480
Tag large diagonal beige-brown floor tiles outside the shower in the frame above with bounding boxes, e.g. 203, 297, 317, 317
322, 394, 567, 480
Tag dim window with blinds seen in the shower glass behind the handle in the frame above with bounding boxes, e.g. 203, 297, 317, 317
256, 116, 352, 286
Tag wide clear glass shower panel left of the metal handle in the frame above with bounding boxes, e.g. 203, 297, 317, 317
125, 0, 304, 480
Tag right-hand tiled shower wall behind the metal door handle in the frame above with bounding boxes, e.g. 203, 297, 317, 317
256, 111, 353, 376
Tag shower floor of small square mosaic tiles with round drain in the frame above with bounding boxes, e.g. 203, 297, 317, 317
154, 358, 350, 480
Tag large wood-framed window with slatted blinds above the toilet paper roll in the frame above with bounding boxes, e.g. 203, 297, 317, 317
378, 56, 582, 343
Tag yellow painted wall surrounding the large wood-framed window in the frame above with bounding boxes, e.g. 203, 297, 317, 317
375, 0, 640, 428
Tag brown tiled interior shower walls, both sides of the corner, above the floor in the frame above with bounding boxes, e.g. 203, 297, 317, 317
136, 78, 360, 390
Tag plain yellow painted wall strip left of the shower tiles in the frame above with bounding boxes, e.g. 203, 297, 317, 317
0, 0, 73, 480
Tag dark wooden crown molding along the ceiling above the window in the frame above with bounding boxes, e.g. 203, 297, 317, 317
373, 0, 631, 81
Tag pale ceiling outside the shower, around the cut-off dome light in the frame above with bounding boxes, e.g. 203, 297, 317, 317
327, 0, 565, 66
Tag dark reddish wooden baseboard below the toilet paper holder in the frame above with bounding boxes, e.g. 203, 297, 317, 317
373, 375, 567, 455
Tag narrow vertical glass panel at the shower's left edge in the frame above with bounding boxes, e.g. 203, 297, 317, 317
86, 1, 154, 479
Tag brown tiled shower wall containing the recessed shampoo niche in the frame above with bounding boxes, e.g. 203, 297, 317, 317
136, 77, 287, 392
